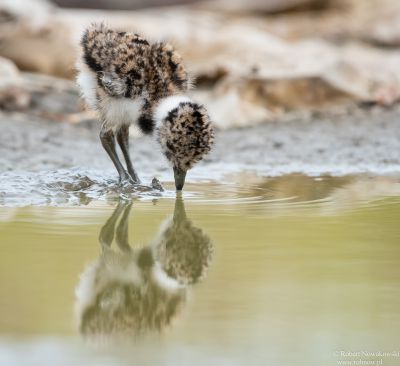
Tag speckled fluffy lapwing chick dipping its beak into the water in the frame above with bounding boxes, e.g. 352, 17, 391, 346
77, 24, 214, 191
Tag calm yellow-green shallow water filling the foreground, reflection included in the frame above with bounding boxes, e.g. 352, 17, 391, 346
0, 174, 400, 366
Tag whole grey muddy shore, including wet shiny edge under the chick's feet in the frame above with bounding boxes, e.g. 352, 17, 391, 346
0, 110, 400, 207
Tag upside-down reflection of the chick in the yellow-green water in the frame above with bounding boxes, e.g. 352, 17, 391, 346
76, 197, 213, 339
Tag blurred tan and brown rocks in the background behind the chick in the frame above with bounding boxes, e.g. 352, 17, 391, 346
0, 0, 400, 128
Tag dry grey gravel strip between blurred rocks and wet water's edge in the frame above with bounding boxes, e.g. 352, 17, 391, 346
0, 106, 400, 178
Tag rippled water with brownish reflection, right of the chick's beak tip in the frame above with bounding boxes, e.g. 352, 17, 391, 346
183, 174, 400, 214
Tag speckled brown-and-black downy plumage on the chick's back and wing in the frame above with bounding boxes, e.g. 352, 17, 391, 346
81, 24, 189, 133
